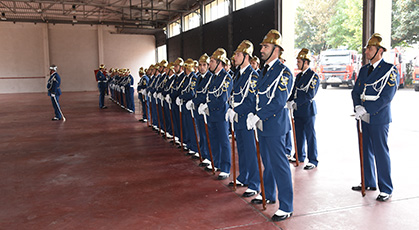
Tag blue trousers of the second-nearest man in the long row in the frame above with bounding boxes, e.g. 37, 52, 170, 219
234, 129, 260, 191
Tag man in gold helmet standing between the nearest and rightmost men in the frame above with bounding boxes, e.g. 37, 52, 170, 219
287, 48, 319, 170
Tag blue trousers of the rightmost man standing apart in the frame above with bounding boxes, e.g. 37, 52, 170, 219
362, 122, 393, 194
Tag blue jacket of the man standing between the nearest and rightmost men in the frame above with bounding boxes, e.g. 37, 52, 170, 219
288, 68, 319, 117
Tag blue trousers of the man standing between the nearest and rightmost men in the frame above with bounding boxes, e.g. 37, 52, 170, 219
294, 116, 318, 166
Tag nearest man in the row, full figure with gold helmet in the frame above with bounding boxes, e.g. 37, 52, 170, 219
246, 30, 293, 221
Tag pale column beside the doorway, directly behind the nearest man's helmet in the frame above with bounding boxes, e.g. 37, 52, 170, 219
277, 0, 297, 68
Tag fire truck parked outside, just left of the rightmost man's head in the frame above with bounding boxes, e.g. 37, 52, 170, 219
320, 49, 360, 89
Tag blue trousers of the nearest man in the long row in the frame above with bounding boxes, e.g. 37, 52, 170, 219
259, 135, 293, 212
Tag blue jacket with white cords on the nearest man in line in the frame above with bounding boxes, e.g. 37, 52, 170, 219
255, 59, 293, 136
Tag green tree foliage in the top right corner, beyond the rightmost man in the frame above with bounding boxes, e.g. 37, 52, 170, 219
391, 0, 419, 47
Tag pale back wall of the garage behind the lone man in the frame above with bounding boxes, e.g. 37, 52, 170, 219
0, 22, 156, 93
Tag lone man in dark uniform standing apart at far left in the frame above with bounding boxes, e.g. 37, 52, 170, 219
47, 65, 63, 121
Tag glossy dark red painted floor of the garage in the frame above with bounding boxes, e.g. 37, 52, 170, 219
0, 92, 419, 230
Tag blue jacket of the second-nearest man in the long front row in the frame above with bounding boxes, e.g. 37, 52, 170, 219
231, 65, 258, 129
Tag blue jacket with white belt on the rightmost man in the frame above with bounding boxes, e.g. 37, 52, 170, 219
352, 60, 400, 124
